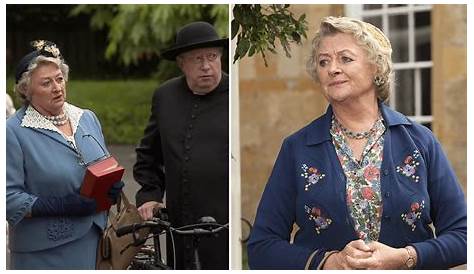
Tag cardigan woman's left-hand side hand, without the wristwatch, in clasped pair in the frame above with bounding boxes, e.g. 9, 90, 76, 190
323, 240, 373, 269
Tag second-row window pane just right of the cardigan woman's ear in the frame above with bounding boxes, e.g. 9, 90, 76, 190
395, 69, 415, 116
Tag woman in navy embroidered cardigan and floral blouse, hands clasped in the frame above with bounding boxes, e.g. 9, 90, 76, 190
248, 17, 467, 269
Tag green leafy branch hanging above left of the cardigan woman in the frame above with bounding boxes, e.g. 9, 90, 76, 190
231, 4, 308, 66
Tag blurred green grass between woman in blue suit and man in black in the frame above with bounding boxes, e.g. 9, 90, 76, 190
7, 79, 158, 144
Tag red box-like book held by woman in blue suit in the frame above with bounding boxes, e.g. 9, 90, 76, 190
81, 156, 125, 212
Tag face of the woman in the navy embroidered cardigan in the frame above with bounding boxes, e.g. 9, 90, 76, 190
317, 33, 376, 103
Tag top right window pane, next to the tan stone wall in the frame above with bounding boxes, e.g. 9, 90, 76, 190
415, 11, 431, 61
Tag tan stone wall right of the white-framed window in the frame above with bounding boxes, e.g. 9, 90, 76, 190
431, 5, 467, 194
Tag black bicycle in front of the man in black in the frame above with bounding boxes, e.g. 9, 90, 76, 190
116, 209, 229, 270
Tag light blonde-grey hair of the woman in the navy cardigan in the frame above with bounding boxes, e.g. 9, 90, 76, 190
306, 16, 394, 102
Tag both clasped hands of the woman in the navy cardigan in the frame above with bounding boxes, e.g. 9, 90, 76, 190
323, 240, 408, 269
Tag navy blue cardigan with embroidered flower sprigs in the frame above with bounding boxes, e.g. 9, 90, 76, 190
248, 104, 467, 269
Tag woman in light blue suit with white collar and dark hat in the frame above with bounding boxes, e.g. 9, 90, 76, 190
6, 41, 123, 269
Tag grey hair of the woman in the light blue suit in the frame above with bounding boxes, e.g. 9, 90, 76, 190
14, 55, 69, 105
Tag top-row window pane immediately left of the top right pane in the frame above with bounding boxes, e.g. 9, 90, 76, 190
388, 15, 408, 63
